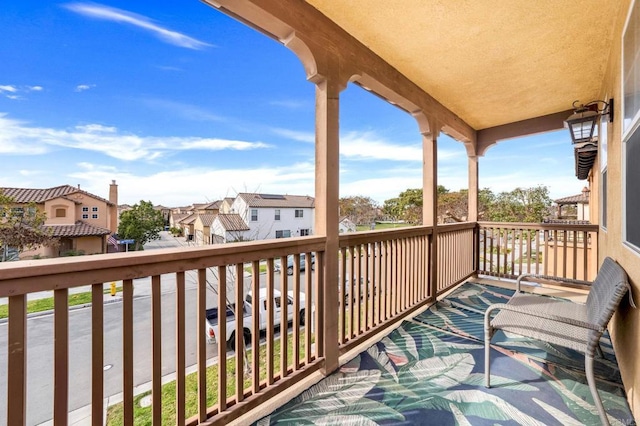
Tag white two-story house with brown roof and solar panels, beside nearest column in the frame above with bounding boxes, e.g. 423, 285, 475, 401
230, 193, 315, 240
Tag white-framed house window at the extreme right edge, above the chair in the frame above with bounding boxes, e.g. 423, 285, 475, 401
622, 1, 640, 251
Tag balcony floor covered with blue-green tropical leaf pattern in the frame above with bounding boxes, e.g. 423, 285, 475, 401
257, 283, 635, 425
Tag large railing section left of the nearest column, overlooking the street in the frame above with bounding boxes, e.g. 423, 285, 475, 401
0, 237, 325, 425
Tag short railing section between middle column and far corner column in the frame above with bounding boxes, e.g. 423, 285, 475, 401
436, 223, 476, 296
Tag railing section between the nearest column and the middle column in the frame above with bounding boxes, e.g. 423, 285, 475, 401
338, 226, 434, 352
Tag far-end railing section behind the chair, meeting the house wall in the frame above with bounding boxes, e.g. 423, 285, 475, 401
477, 222, 598, 281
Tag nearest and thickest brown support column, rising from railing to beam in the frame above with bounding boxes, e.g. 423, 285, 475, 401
315, 79, 340, 374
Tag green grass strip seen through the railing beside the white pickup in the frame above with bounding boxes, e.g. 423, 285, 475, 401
107, 331, 305, 426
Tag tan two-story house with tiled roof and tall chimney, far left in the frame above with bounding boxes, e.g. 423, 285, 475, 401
0, 181, 118, 258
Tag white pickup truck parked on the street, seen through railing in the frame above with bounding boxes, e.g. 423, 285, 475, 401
206, 288, 306, 348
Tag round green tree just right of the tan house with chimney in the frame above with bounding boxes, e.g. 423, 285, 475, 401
118, 200, 164, 250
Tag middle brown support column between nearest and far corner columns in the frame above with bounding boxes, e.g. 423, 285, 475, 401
422, 132, 438, 297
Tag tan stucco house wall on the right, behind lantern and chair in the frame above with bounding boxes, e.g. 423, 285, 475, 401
594, 0, 640, 418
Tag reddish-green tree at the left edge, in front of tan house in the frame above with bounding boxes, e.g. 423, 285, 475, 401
0, 191, 58, 262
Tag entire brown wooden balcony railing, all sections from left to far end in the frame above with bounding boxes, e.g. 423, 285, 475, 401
0, 223, 597, 425
